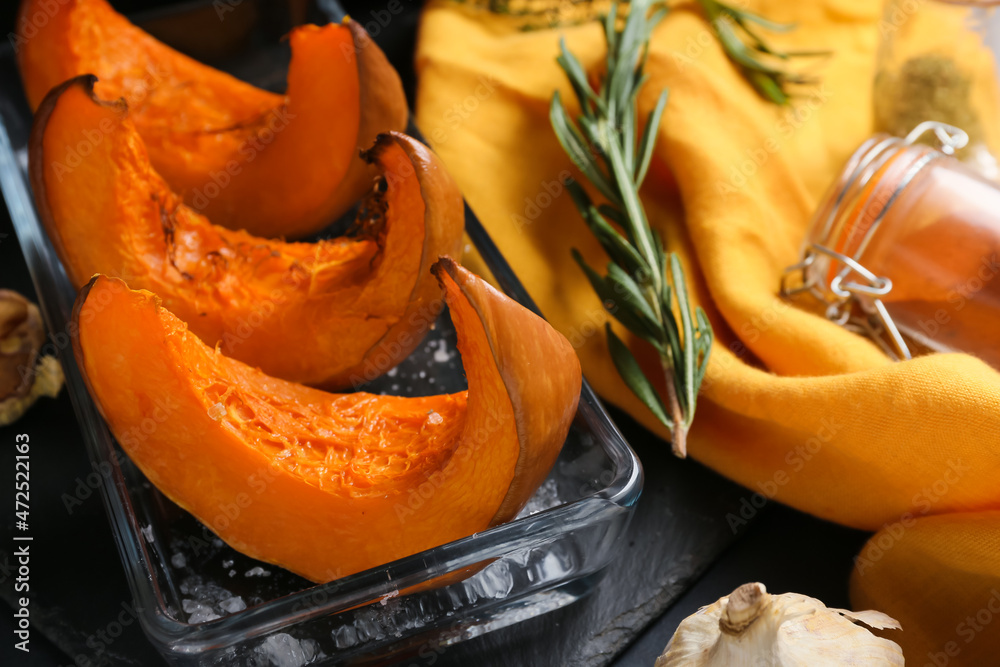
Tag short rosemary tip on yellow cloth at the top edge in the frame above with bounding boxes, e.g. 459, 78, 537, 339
698, 0, 829, 104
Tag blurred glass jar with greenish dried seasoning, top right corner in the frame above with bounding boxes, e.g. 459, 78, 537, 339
873, 0, 1000, 179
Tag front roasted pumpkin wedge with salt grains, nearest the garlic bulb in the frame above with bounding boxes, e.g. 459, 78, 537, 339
74, 260, 581, 581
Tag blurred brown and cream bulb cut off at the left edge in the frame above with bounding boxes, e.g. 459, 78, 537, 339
0, 290, 63, 426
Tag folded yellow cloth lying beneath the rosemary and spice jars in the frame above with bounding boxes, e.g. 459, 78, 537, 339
417, 0, 1000, 664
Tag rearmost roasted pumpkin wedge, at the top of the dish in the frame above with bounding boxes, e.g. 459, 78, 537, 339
17, 0, 407, 238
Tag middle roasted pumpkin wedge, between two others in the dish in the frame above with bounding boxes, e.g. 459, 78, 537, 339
29, 76, 463, 388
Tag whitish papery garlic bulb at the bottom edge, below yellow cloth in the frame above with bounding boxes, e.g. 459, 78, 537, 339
655, 583, 903, 667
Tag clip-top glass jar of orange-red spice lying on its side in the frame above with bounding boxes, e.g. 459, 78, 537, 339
782, 122, 1000, 369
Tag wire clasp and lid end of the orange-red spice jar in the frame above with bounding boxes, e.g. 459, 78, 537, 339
781, 121, 969, 359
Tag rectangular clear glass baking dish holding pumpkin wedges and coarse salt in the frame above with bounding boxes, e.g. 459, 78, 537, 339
0, 0, 642, 667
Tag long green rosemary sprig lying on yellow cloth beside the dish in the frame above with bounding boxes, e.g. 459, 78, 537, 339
549, 0, 712, 457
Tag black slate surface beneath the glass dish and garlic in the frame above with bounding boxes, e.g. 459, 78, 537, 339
0, 0, 866, 667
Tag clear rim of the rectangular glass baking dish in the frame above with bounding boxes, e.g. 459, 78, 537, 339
0, 32, 643, 653
